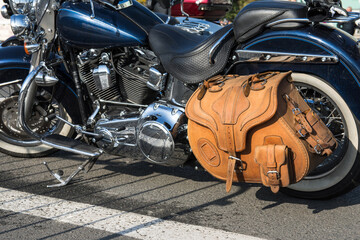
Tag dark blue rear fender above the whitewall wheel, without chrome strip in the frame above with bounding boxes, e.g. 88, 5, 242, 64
235, 24, 360, 119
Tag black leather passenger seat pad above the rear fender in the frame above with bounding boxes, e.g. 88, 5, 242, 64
234, 1, 307, 43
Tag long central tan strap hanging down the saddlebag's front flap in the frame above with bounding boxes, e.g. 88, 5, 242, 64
226, 125, 236, 192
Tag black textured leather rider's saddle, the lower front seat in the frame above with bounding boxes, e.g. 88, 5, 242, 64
149, 24, 235, 83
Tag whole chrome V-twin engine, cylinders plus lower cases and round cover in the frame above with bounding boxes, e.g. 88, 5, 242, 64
77, 48, 190, 166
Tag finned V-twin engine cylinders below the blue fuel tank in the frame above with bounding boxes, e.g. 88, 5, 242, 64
77, 48, 166, 104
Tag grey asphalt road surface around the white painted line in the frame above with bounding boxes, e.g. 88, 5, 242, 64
0, 151, 360, 240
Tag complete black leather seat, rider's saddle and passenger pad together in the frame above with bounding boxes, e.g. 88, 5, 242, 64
149, 1, 307, 83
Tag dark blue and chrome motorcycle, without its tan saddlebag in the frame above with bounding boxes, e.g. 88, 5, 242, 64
0, 0, 360, 198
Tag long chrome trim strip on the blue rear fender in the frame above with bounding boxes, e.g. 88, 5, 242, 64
235, 50, 339, 64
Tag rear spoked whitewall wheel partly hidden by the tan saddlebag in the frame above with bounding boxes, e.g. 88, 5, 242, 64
282, 73, 360, 199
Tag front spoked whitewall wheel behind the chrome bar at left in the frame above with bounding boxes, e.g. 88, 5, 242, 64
0, 80, 73, 157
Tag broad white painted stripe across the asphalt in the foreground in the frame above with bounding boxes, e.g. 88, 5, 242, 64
0, 187, 260, 240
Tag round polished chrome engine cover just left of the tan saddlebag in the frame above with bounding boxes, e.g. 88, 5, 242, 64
137, 103, 190, 166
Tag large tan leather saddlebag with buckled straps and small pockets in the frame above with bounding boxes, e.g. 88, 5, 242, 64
186, 72, 337, 192
